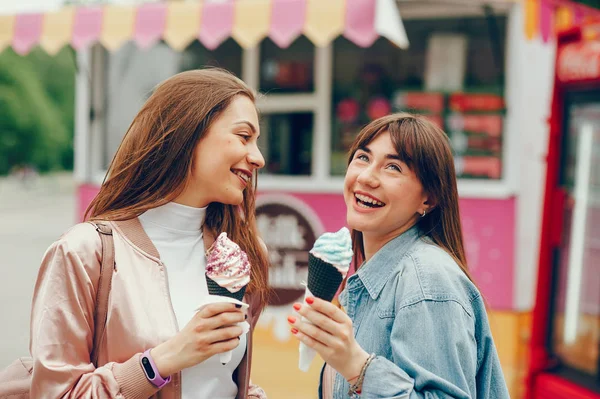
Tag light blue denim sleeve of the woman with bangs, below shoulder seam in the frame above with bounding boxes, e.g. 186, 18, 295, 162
361, 300, 485, 399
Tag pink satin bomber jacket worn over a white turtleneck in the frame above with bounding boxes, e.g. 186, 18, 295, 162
30, 218, 265, 399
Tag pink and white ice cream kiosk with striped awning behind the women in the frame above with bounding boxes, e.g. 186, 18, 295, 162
0, 0, 588, 398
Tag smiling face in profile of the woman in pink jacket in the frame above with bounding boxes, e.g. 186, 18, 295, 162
175, 95, 265, 207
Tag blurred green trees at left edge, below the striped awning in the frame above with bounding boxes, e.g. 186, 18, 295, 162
0, 47, 75, 175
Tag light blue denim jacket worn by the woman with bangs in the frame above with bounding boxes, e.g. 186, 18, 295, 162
324, 227, 509, 399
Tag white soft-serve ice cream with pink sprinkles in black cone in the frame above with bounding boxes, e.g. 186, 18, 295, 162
206, 232, 250, 300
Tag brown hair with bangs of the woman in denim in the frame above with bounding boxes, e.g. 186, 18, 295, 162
348, 113, 471, 279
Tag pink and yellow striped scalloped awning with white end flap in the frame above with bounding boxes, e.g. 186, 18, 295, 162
0, 0, 408, 54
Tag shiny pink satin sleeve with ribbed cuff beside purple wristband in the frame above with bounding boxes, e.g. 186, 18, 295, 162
30, 238, 157, 399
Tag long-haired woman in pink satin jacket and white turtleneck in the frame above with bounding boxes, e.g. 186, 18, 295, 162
31, 69, 267, 399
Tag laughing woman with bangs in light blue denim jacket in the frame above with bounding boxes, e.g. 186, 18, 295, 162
289, 113, 509, 399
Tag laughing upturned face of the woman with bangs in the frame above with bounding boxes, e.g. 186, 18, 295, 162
344, 131, 429, 243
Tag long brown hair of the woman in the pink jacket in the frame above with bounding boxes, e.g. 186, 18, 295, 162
85, 68, 268, 309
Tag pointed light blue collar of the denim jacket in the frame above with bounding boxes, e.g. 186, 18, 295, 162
356, 226, 420, 299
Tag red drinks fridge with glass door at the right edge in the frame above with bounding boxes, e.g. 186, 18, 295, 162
527, 16, 600, 399
